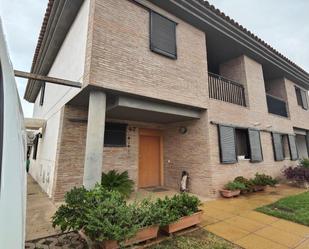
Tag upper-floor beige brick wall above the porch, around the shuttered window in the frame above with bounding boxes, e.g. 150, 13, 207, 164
85, 0, 207, 107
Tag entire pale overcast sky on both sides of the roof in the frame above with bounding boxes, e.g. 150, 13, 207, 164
0, 0, 309, 117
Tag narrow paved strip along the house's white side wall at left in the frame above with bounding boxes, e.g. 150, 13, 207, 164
26, 175, 59, 241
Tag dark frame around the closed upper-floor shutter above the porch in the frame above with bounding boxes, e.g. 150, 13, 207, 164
149, 10, 178, 60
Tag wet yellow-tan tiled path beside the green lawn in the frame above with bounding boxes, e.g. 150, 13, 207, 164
203, 185, 309, 249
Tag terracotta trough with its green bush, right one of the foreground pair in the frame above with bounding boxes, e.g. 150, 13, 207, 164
155, 193, 202, 234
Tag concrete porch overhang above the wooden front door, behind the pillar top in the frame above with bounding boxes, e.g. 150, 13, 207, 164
68, 86, 206, 124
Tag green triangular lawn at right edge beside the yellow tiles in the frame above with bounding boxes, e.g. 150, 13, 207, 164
256, 192, 309, 226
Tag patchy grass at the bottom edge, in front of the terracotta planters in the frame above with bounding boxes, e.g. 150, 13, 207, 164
150, 229, 240, 249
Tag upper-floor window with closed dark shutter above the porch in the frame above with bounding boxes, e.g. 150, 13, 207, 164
150, 11, 177, 59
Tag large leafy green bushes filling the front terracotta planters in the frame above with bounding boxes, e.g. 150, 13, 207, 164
52, 187, 201, 242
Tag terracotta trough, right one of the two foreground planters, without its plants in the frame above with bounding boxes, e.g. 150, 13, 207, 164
161, 211, 203, 234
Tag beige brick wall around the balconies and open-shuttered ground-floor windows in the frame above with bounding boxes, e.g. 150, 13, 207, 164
208, 56, 309, 194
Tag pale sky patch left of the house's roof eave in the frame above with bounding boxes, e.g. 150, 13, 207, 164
0, 0, 47, 117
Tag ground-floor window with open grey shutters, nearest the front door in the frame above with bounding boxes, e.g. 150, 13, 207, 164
218, 125, 263, 163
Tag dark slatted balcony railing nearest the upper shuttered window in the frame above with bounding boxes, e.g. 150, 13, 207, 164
208, 73, 246, 106
